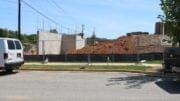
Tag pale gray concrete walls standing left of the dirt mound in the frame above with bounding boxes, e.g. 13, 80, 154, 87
38, 31, 86, 55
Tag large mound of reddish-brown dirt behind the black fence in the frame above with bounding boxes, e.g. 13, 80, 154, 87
66, 33, 169, 54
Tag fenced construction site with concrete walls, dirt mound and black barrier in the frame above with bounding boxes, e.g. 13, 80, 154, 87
25, 32, 172, 62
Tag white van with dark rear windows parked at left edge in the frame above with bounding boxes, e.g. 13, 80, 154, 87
0, 38, 24, 72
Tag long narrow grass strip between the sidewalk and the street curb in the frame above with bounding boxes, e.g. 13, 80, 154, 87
21, 65, 151, 71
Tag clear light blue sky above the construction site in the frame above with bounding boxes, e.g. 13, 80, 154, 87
0, 0, 162, 39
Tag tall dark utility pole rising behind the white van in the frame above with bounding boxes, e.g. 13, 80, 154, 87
18, 0, 21, 40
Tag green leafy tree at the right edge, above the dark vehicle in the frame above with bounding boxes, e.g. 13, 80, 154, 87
158, 0, 180, 47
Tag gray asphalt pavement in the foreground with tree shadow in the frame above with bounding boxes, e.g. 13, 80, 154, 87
0, 71, 180, 101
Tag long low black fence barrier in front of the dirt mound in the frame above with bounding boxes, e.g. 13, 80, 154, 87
24, 53, 163, 63
